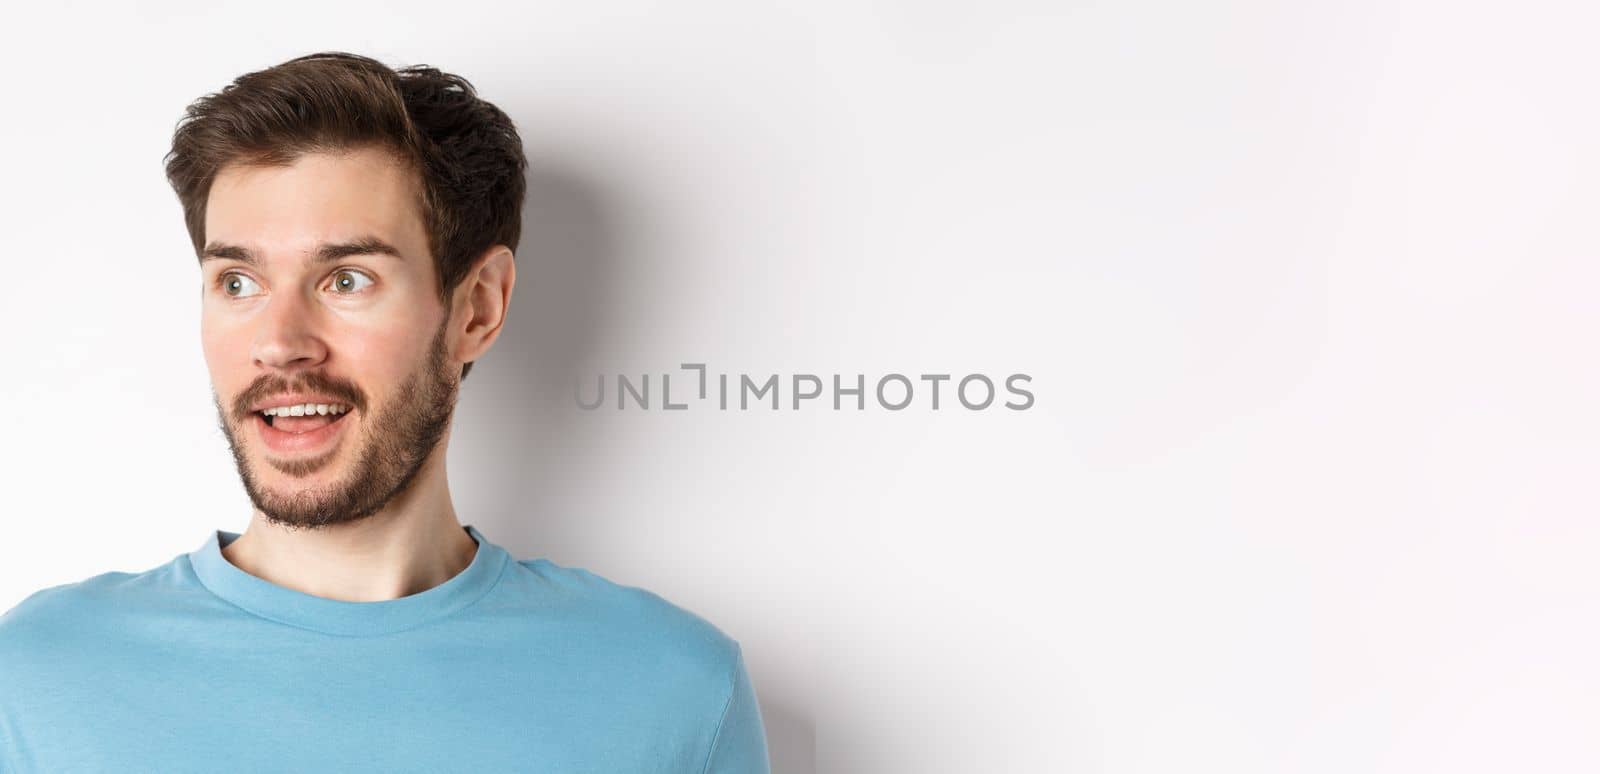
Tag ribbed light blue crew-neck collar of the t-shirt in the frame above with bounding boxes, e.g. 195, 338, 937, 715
189, 525, 510, 636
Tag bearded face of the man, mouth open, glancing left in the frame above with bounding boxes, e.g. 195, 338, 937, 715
200, 149, 461, 528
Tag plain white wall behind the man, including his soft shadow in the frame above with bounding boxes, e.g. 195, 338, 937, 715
0, 0, 1600, 774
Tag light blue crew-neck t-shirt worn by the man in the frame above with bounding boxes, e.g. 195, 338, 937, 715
0, 526, 768, 774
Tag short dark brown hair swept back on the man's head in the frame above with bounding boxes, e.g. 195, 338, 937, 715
165, 51, 528, 379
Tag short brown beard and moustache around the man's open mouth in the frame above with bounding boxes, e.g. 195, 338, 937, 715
211, 313, 461, 529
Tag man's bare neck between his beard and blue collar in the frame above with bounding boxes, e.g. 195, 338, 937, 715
222, 470, 477, 601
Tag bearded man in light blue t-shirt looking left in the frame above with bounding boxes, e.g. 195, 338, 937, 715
0, 53, 768, 774
